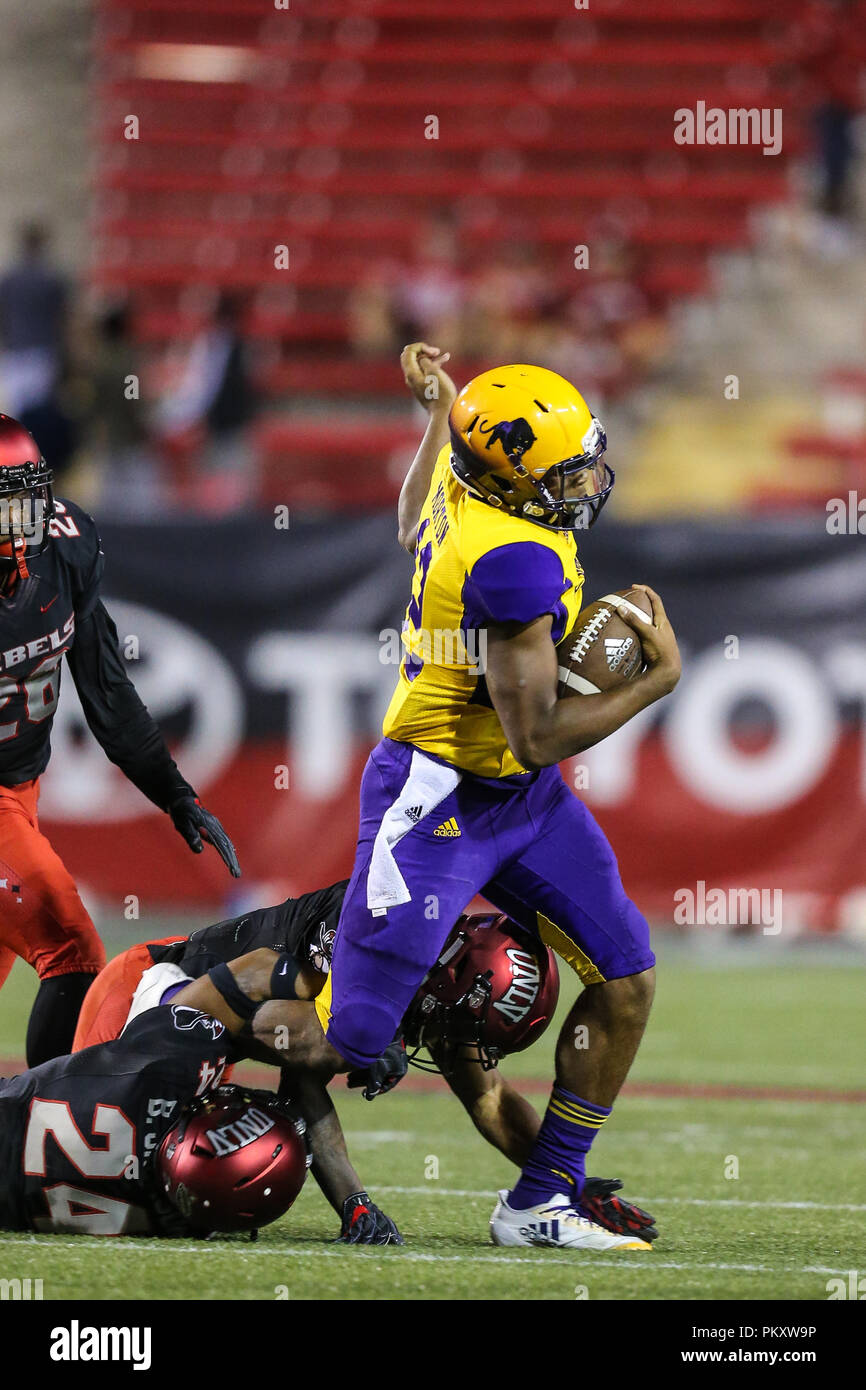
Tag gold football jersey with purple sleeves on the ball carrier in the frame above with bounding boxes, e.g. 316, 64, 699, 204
382, 445, 584, 777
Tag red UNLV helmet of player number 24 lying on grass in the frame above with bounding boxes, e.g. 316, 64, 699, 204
156, 1086, 310, 1232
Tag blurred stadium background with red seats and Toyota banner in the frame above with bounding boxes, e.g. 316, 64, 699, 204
0, 0, 866, 945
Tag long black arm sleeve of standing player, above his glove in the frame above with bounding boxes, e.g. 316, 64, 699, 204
67, 594, 195, 810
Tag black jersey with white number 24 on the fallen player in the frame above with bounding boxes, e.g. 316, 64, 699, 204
0, 1004, 238, 1236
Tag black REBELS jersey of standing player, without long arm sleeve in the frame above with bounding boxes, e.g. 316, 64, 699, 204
0, 502, 103, 787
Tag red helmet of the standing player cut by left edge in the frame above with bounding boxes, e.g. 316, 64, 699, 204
0, 414, 54, 578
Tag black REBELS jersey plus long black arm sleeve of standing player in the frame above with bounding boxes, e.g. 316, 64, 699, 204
0, 502, 193, 810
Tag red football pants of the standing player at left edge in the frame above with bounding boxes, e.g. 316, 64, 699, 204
0, 777, 106, 986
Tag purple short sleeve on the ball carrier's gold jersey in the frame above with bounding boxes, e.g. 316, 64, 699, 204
463, 541, 571, 642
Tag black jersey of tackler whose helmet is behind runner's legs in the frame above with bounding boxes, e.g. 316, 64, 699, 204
147, 878, 349, 980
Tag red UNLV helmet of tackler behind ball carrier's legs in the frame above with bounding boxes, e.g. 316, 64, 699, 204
403, 912, 559, 1070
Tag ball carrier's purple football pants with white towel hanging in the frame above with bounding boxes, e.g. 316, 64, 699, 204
317, 738, 655, 1066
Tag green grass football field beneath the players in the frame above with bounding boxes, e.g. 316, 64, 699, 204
0, 922, 866, 1300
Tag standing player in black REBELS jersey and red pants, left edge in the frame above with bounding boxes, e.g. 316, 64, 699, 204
0, 416, 240, 1066
